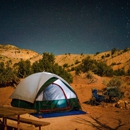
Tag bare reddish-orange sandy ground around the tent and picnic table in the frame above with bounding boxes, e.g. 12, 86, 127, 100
0, 74, 130, 130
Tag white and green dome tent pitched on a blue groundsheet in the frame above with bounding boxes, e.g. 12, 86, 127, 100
10, 72, 81, 113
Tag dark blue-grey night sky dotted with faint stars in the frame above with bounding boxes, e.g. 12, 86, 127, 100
0, 0, 130, 55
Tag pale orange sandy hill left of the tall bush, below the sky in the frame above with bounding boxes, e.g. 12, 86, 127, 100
0, 44, 42, 64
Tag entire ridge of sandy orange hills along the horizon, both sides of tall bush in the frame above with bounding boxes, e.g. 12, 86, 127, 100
0, 44, 130, 70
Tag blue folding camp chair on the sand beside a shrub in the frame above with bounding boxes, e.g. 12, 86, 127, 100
91, 89, 105, 105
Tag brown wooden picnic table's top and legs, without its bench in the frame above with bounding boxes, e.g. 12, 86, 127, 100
0, 106, 36, 130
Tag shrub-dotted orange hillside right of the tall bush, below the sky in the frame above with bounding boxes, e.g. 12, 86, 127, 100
55, 48, 130, 71
